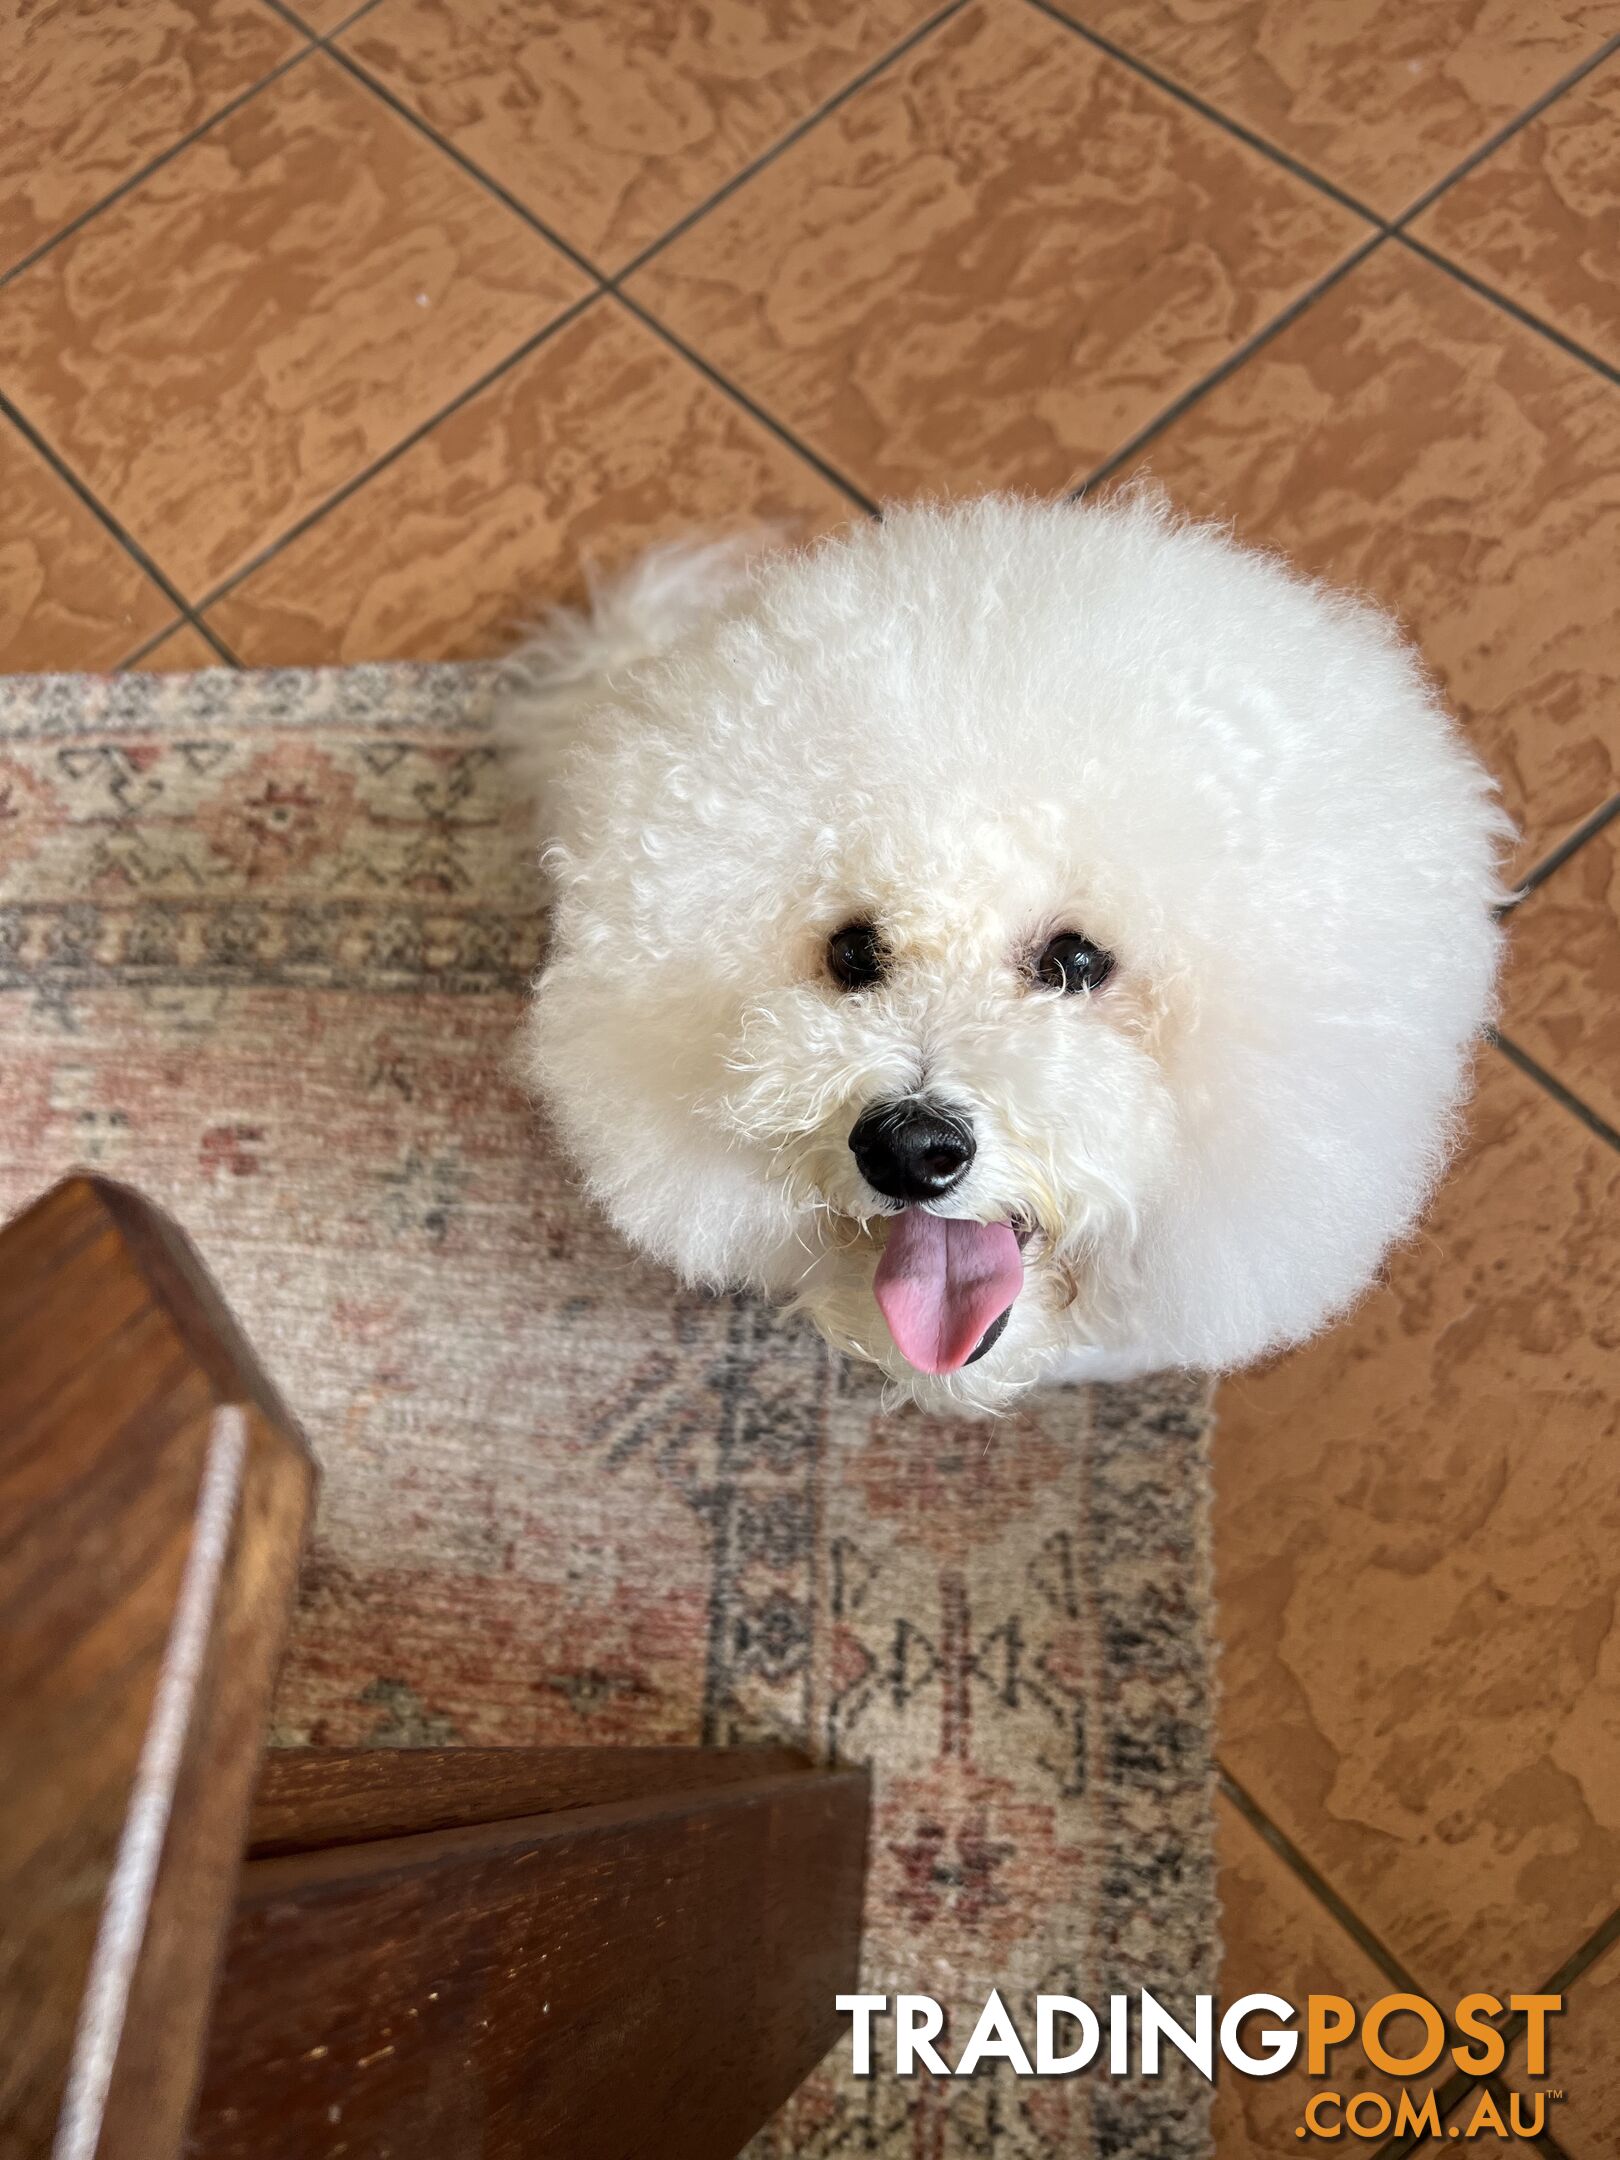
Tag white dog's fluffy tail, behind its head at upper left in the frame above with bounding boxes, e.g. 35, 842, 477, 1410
497, 531, 778, 801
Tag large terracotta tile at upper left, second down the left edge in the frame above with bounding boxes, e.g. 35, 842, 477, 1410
0, 52, 588, 598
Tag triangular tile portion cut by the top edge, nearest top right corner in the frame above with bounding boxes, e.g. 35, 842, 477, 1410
1058, 0, 1620, 218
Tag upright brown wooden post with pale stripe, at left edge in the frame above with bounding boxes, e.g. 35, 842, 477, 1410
0, 1177, 313, 2160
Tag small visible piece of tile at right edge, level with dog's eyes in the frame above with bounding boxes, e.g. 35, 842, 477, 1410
1501, 821, 1620, 1140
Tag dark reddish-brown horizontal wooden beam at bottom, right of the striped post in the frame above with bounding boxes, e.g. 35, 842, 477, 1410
190, 1747, 868, 2160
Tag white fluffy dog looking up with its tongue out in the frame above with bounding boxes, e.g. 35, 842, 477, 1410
505, 495, 1508, 1408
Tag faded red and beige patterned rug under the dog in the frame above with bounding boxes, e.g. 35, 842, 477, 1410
0, 667, 1216, 2160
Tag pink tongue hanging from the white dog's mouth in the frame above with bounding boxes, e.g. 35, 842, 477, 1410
873, 1207, 1024, 1372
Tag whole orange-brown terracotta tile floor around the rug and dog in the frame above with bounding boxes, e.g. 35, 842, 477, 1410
0, 0, 1620, 2160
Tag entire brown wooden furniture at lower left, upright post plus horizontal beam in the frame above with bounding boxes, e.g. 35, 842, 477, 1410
0, 1177, 868, 2160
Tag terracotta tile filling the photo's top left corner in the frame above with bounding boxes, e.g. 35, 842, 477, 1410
0, 0, 302, 272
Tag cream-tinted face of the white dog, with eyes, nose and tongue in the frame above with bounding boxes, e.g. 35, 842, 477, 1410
708, 807, 1175, 1402
